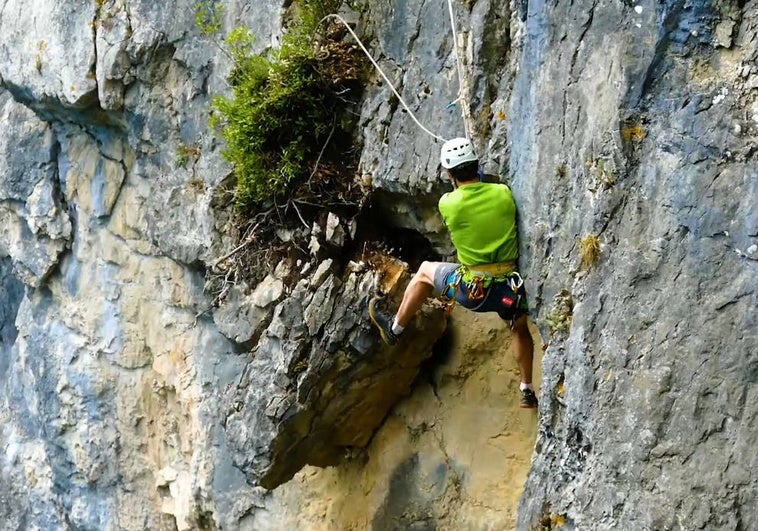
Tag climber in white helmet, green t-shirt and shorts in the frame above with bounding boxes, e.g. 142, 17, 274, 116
369, 138, 537, 408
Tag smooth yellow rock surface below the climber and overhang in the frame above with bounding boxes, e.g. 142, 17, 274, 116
270, 308, 541, 531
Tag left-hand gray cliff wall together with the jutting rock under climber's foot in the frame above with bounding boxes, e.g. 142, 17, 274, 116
0, 1, 452, 529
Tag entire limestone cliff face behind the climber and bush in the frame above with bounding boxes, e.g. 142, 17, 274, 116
0, 0, 758, 529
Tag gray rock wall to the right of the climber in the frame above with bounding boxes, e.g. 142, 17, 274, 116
510, 2, 758, 529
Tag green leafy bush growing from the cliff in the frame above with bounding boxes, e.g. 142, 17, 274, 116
206, 0, 356, 211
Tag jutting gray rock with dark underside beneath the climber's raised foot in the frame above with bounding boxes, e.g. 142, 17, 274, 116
224, 260, 445, 489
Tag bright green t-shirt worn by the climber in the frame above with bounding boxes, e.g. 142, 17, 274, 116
439, 183, 518, 266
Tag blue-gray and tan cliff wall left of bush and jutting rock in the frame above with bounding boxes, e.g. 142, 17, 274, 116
0, 1, 288, 529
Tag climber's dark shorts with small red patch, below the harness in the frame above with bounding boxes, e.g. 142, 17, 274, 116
434, 263, 529, 321
